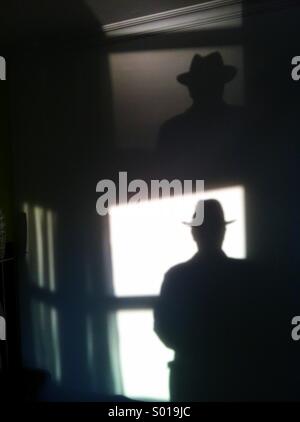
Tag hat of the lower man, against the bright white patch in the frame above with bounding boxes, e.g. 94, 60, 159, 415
184, 199, 235, 227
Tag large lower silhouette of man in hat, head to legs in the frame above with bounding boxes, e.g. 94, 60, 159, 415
154, 199, 255, 401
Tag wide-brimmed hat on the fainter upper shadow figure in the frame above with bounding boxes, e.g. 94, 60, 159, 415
177, 51, 237, 86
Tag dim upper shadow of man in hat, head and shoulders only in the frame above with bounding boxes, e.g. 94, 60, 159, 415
158, 52, 244, 175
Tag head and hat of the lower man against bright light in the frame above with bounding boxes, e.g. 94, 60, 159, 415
188, 199, 233, 254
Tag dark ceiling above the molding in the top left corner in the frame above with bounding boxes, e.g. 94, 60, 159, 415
0, 0, 209, 45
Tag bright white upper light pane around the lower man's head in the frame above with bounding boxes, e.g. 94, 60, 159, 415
110, 186, 246, 296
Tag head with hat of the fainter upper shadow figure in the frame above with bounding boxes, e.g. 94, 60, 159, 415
177, 52, 237, 106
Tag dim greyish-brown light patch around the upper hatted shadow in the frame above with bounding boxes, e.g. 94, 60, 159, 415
108, 47, 245, 149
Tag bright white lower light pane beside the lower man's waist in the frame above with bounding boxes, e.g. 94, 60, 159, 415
117, 310, 174, 400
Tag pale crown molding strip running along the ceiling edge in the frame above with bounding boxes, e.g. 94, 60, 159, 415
103, 0, 299, 38
